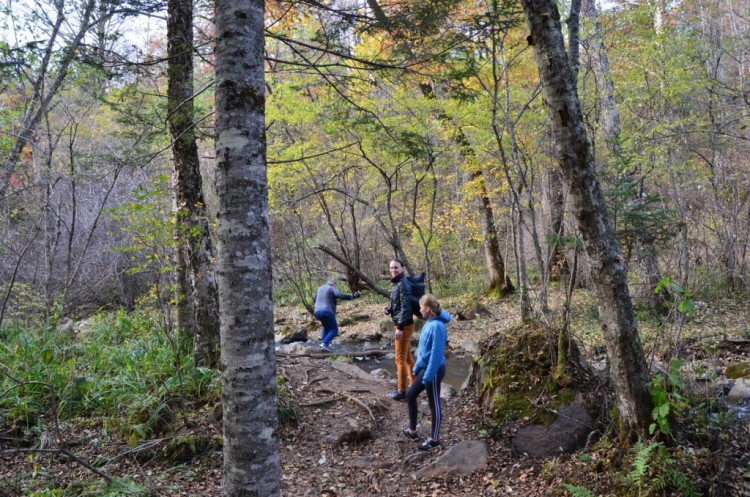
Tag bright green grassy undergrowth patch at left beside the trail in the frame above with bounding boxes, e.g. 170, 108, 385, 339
0, 311, 221, 443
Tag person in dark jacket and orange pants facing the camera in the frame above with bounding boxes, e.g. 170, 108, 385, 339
385, 259, 414, 400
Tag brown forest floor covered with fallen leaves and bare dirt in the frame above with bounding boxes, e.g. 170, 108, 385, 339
0, 292, 750, 497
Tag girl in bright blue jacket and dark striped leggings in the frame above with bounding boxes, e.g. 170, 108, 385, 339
403, 294, 451, 450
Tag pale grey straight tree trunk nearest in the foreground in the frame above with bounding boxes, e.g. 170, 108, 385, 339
215, 0, 280, 497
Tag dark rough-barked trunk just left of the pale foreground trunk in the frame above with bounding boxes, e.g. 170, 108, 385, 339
167, 0, 220, 367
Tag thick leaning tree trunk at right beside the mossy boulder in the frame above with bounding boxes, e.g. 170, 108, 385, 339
521, 0, 652, 435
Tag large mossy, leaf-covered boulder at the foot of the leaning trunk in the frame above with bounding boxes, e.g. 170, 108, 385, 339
467, 322, 605, 457
